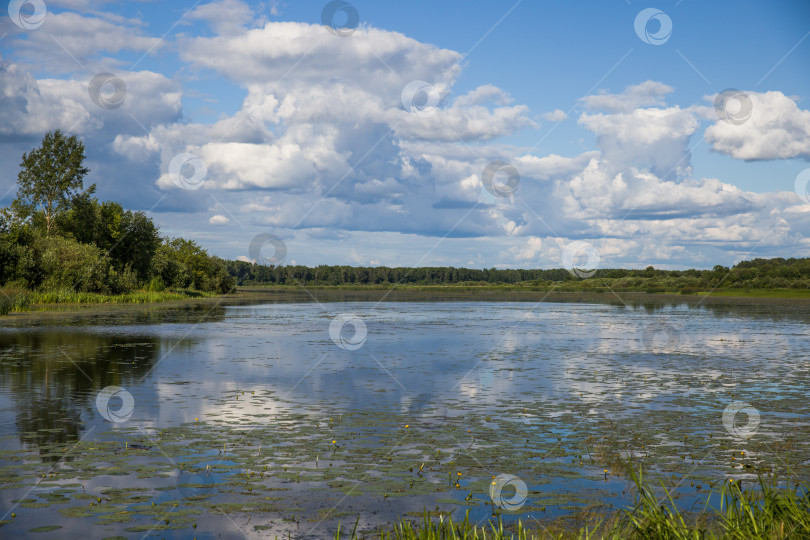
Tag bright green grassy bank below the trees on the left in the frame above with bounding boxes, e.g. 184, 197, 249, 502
0, 288, 217, 315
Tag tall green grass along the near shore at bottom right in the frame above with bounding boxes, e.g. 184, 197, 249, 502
335, 472, 810, 540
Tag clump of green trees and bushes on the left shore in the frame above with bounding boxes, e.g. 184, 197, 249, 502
0, 130, 234, 294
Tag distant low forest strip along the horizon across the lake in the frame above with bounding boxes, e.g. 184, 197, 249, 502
225, 258, 810, 292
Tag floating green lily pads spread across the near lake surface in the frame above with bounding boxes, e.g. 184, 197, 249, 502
0, 374, 810, 534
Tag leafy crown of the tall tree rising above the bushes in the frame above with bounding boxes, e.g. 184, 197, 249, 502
14, 130, 94, 234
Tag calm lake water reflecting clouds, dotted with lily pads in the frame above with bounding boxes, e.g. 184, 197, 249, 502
0, 299, 810, 538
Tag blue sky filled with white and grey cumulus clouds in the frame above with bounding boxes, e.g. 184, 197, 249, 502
0, 0, 810, 269
